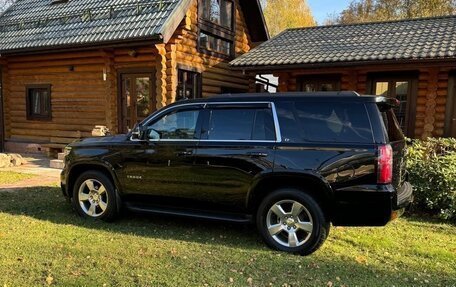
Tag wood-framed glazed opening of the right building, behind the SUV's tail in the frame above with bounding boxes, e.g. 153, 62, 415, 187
371, 76, 417, 137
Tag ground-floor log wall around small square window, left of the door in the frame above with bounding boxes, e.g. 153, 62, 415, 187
2, 47, 156, 144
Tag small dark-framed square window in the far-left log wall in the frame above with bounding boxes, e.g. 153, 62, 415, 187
26, 85, 51, 120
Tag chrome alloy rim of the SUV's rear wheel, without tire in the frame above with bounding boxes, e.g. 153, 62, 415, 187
266, 200, 313, 247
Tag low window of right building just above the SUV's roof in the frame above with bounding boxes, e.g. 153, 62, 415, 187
297, 75, 340, 92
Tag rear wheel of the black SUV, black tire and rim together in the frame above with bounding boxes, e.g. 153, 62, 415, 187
256, 188, 330, 256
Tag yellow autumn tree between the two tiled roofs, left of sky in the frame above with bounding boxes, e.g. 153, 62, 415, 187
262, 0, 316, 36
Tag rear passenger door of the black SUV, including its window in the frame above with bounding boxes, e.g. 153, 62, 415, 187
195, 103, 278, 212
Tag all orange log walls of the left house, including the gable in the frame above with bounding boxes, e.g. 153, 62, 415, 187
0, 0, 253, 151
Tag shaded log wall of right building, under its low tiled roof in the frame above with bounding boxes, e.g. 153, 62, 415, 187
274, 61, 456, 138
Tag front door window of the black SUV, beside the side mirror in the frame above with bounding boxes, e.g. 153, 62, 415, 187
146, 109, 200, 141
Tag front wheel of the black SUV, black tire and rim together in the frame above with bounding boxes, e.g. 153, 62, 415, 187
71, 171, 118, 222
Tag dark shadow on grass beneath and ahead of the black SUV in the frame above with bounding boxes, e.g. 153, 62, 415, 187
0, 187, 266, 252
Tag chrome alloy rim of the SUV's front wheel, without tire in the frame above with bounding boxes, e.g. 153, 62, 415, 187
78, 179, 109, 217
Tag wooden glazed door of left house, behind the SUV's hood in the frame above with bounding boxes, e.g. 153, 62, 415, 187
119, 73, 157, 133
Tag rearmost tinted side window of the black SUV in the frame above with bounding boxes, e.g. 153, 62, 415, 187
277, 102, 373, 143
